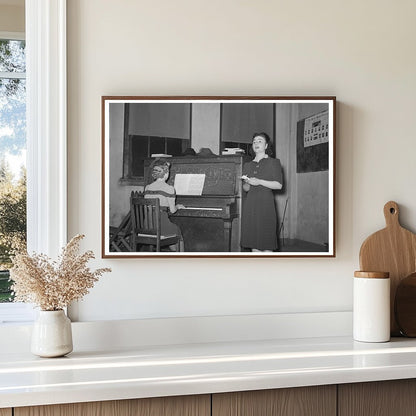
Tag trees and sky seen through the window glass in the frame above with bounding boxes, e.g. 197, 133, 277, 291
0, 39, 26, 302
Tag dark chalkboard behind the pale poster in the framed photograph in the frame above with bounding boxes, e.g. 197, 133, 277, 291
296, 119, 329, 173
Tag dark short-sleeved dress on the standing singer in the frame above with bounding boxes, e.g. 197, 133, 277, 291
241, 157, 282, 250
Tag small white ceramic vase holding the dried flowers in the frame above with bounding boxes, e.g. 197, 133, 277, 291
31, 310, 72, 358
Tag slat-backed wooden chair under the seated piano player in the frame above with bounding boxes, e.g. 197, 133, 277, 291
130, 191, 181, 252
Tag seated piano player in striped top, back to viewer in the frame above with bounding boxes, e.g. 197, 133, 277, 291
144, 159, 184, 251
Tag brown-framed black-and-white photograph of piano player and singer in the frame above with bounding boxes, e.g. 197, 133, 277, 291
102, 96, 336, 258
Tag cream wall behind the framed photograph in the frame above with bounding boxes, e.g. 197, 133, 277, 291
68, 0, 416, 321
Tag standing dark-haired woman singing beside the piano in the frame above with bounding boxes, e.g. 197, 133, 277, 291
241, 133, 283, 251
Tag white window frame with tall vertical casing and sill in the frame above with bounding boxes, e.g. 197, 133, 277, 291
0, 0, 67, 323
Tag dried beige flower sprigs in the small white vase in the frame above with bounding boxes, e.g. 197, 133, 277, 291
10, 234, 111, 311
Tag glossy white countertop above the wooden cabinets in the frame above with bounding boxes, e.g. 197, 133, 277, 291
0, 334, 416, 408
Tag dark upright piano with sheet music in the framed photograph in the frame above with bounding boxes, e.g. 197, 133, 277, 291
145, 155, 246, 252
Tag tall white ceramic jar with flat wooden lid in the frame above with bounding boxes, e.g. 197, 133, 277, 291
353, 271, 390, 342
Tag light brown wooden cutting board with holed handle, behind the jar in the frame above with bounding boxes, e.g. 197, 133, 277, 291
360, 201, 416, 336
